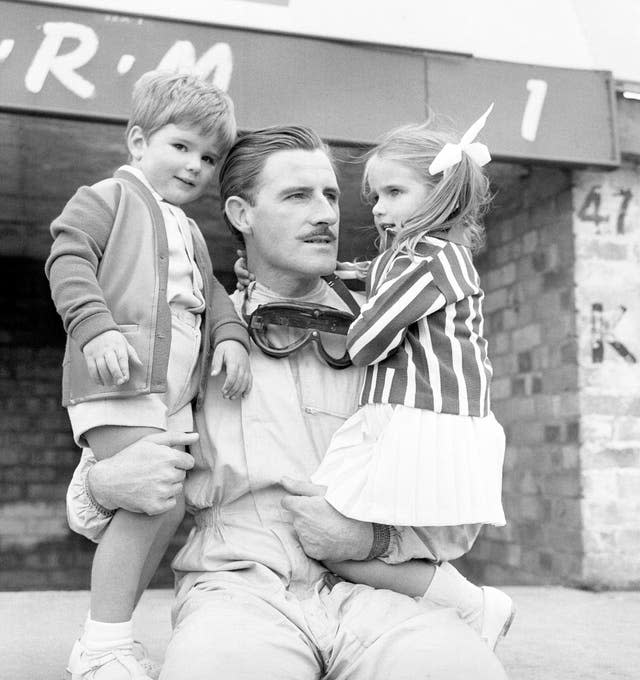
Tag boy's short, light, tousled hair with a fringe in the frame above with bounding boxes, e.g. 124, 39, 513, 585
126, 71, 236, 157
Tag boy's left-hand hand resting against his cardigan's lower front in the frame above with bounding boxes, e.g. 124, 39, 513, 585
82, 331, 142, 385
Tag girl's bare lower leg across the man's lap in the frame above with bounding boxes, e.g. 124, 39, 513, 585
324, 560, 435, 597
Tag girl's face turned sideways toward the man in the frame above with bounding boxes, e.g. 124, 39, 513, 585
367, 156, 433, 238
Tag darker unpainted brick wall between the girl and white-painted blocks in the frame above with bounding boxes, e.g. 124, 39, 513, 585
462, 167, 583, 584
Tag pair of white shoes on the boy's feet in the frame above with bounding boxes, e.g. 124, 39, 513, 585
65, 640, 160, 680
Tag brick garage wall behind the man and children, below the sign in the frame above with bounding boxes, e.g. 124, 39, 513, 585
0, 114, 640, 589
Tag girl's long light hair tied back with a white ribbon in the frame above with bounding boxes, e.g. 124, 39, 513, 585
362, 121, 491, 254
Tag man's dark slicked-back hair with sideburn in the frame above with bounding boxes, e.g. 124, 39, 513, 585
219, 125, 335, 241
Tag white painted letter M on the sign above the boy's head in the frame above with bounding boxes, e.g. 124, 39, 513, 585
158, 40, 233, 92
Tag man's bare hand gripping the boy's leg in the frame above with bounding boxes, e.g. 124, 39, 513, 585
88, 432, 198, 515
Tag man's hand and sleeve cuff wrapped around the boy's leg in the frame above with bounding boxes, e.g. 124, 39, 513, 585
67, 432, 198, 541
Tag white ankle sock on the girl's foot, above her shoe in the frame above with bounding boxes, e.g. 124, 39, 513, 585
423, 562, 484, 627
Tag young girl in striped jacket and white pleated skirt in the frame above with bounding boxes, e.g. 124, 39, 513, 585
237, 109, 514, 649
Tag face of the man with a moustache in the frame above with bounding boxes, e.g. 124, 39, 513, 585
246, 149, 340, 286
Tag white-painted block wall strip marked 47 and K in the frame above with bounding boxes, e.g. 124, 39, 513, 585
573, 162, 640, 588
